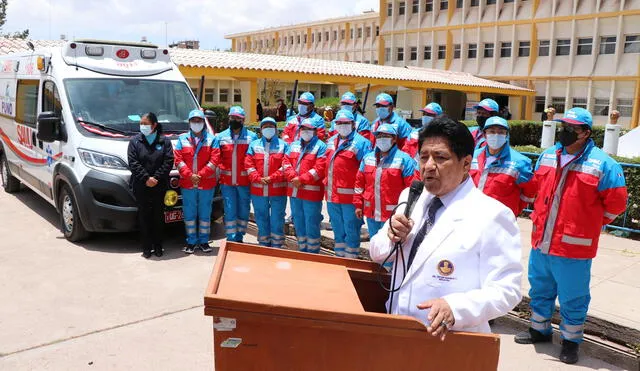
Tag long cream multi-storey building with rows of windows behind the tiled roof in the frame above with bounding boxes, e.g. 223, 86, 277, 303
222, 0, 640, 127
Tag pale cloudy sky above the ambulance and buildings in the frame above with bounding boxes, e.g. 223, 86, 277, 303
2, 0, 380, 49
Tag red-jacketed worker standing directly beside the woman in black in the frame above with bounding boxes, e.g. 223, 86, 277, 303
174, 109, 216, 254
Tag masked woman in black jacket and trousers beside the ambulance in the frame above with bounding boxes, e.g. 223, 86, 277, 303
128, 112, 173, 258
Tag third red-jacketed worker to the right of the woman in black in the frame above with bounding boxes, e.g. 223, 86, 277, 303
244, 117, 289, 248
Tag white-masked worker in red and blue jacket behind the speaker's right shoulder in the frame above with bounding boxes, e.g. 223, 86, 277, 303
469, 116, 537, 217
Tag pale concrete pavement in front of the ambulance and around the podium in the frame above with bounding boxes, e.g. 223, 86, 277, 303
0, 191, 638, 370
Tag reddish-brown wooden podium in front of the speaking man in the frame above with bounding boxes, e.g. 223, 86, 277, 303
204, 242, 500, 371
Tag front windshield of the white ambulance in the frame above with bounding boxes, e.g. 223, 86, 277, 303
64, 78, 198, 134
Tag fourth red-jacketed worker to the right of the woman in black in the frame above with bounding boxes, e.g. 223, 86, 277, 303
283, 119, 327, 254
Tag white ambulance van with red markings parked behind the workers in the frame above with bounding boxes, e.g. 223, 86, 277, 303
0, 40, 216, 241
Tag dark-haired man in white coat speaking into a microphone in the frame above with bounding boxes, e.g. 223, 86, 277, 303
370, 117, 522, 340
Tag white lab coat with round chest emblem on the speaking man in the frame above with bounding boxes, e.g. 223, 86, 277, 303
370, 178, 522, 333
